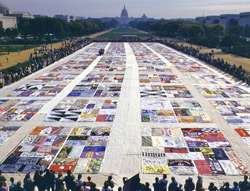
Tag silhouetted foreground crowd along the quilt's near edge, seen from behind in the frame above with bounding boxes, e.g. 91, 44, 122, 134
0, 169, 250, 191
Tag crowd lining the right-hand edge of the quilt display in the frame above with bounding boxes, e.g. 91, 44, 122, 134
158, 40, 250, 85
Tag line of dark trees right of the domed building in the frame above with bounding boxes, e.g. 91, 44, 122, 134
135, 20, 250, 58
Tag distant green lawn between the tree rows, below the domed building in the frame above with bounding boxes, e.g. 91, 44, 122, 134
95, 29, 148, 39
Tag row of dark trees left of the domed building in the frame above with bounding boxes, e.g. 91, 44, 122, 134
0, 17, 108, 40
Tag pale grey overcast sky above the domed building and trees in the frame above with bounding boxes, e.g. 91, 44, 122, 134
0, 0, 250, 18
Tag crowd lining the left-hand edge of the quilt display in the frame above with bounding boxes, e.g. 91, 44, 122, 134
0, 40, 90, 88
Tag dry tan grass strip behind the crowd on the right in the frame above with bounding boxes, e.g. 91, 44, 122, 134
178, 43, 250, 72
